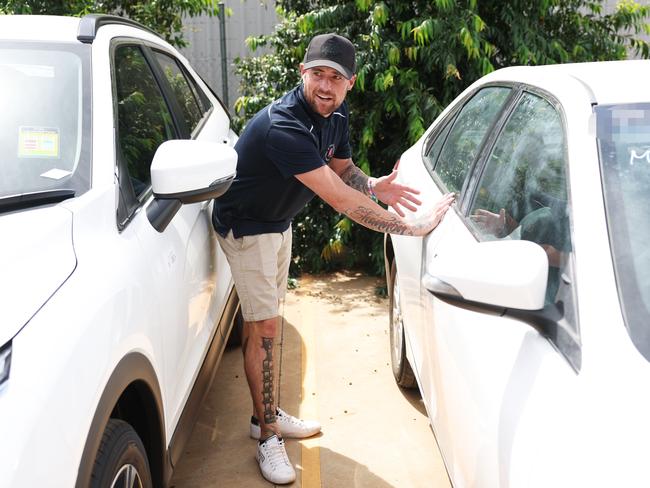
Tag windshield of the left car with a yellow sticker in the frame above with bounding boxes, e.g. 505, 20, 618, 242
0, 42, 90, 208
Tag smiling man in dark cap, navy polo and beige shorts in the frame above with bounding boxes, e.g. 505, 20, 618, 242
213, 34, 453, 484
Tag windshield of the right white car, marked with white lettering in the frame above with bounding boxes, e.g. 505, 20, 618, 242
596, 103, 650, 361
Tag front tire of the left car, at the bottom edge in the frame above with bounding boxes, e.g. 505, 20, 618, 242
90, 419, 153, 488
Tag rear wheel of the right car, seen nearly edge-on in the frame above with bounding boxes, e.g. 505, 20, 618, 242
389, 261, 417, 388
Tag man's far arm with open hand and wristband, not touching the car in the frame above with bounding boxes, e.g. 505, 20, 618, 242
329, 158, 422, 217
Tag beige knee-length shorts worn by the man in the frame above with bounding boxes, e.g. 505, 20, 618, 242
217, 226, 291, 322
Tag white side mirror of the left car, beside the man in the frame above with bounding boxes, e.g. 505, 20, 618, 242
147, 139, 237, 232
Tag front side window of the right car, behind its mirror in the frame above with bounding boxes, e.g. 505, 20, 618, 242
470, 93, 571, 304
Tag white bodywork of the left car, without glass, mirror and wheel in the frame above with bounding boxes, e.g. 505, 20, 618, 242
0, 16, 236, 488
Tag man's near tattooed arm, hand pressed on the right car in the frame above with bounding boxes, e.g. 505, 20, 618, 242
296, 166, 453, 236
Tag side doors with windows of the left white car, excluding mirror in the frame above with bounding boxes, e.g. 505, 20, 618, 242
113, 41, 230, 435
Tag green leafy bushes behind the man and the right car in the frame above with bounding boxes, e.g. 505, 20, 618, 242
235, 0, 650, 273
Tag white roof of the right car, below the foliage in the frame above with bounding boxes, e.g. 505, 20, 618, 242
483, 60, 650, 105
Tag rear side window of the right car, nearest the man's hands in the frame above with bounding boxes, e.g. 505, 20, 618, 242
425, 87, 511, 192
